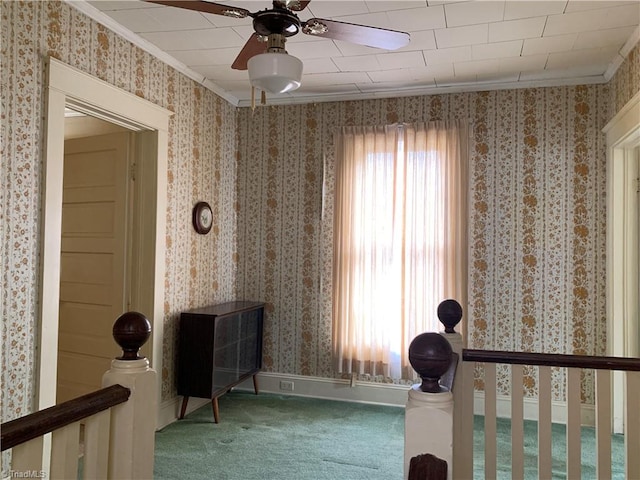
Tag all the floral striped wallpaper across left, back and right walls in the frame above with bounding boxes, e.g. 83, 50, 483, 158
0, 1, 640, 421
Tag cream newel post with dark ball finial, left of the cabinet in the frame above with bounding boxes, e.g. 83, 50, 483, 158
102, 312, 157, 480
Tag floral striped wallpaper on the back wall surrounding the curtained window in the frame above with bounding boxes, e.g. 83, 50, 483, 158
238, 85, 608, 402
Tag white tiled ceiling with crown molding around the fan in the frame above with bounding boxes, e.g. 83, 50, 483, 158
81, 0, 640, 106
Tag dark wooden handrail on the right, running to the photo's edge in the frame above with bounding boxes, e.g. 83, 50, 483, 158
462, 349, 640, 372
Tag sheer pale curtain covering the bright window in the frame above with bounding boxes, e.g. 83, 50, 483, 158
333, 122, 468, 379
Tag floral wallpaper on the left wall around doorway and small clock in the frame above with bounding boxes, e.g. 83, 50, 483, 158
0, 1, 236, 421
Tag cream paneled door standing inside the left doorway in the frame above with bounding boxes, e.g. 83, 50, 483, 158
56, 132, 132, 403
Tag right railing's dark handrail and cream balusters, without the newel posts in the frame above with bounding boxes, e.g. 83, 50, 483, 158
454, 349, 640, 480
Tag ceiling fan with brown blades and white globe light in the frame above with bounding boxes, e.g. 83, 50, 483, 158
146, 0, 409, 93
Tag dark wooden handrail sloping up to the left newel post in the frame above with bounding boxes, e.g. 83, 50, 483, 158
0, 385, 131, 451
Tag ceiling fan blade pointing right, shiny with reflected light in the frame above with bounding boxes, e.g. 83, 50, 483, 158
302, 18, 411, 50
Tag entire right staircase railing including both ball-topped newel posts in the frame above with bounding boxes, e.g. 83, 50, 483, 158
405, 300, 640, 480
